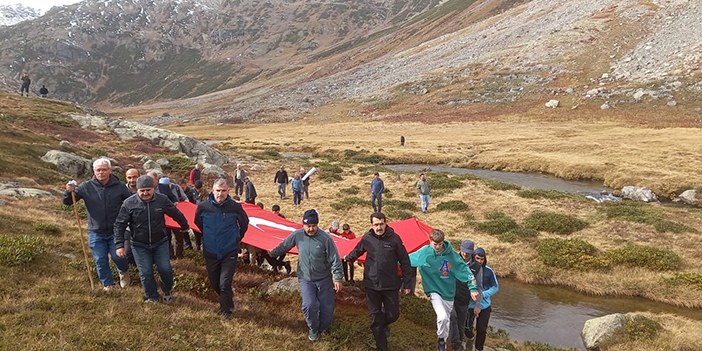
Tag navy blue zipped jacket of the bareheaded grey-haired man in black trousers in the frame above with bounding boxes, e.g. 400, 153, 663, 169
195, 193, 249, 260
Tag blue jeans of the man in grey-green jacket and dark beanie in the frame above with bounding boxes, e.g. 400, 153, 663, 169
298, 275, 334, 332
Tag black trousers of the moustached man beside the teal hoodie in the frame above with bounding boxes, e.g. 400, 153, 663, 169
366, 288, 400, 351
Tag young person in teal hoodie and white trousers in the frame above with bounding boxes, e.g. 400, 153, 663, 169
409, 229, 480, 351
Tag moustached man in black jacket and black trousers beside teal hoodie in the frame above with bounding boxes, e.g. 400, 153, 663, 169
344, 212, 412, 351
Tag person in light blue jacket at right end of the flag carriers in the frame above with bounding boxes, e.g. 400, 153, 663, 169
466, 247, 500, 351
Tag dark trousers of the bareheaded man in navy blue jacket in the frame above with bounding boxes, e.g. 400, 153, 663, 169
205, 250, 237, 313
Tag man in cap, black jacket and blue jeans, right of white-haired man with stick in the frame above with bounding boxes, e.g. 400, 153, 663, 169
114, 175, 188, 304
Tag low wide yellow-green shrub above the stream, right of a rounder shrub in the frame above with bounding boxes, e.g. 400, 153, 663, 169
602, 245, 680, 271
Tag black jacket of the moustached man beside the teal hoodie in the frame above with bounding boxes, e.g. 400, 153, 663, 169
346, 226, 413, 290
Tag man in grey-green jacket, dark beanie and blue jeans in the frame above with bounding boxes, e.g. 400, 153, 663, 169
270, 209, 342, 341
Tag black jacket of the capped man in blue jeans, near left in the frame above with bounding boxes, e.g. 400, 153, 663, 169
114, 192, 188, 249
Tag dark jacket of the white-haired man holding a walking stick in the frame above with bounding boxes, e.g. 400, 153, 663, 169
63, 174, 132, 235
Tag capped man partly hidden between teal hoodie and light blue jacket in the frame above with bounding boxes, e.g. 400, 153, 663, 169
449, 240, 483, 350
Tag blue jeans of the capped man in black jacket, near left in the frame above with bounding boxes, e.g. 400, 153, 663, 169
132, 241, 173, 300
